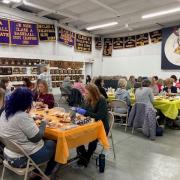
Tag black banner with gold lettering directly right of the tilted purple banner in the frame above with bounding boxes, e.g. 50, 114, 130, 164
75, 34, 92, 52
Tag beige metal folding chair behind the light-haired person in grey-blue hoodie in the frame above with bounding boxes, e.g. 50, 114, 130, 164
110, 99, 128, 132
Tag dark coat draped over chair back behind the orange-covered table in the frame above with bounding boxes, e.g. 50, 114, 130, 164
68, 88, 84, 106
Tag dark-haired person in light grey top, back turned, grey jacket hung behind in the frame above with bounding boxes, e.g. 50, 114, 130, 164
135, 79, 154, 107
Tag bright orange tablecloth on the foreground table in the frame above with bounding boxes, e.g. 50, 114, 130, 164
31, 111, 109, 164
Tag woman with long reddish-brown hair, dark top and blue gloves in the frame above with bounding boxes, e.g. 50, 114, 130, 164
76, 83, 109, 167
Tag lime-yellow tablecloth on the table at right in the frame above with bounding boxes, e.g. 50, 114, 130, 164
108, 95, 180, 120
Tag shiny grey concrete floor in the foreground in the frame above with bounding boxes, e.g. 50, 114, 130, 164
1, 125, 180, 180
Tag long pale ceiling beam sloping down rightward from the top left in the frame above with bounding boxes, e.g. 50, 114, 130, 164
23, 0, 79, 19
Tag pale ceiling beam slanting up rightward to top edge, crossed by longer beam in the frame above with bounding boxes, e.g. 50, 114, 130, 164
38, 0, 83, 17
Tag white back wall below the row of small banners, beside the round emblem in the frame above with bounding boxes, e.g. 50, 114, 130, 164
102, 43, 180, 78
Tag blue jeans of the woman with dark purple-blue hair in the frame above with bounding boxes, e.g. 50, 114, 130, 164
5, 140, 57, 175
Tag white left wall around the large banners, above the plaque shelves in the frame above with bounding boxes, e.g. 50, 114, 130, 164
0, 6, 102, 76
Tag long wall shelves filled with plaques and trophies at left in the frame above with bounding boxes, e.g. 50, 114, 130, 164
0, 58, 84, 88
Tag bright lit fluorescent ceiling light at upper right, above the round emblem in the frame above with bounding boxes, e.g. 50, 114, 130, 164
142, 7, 180, 19
